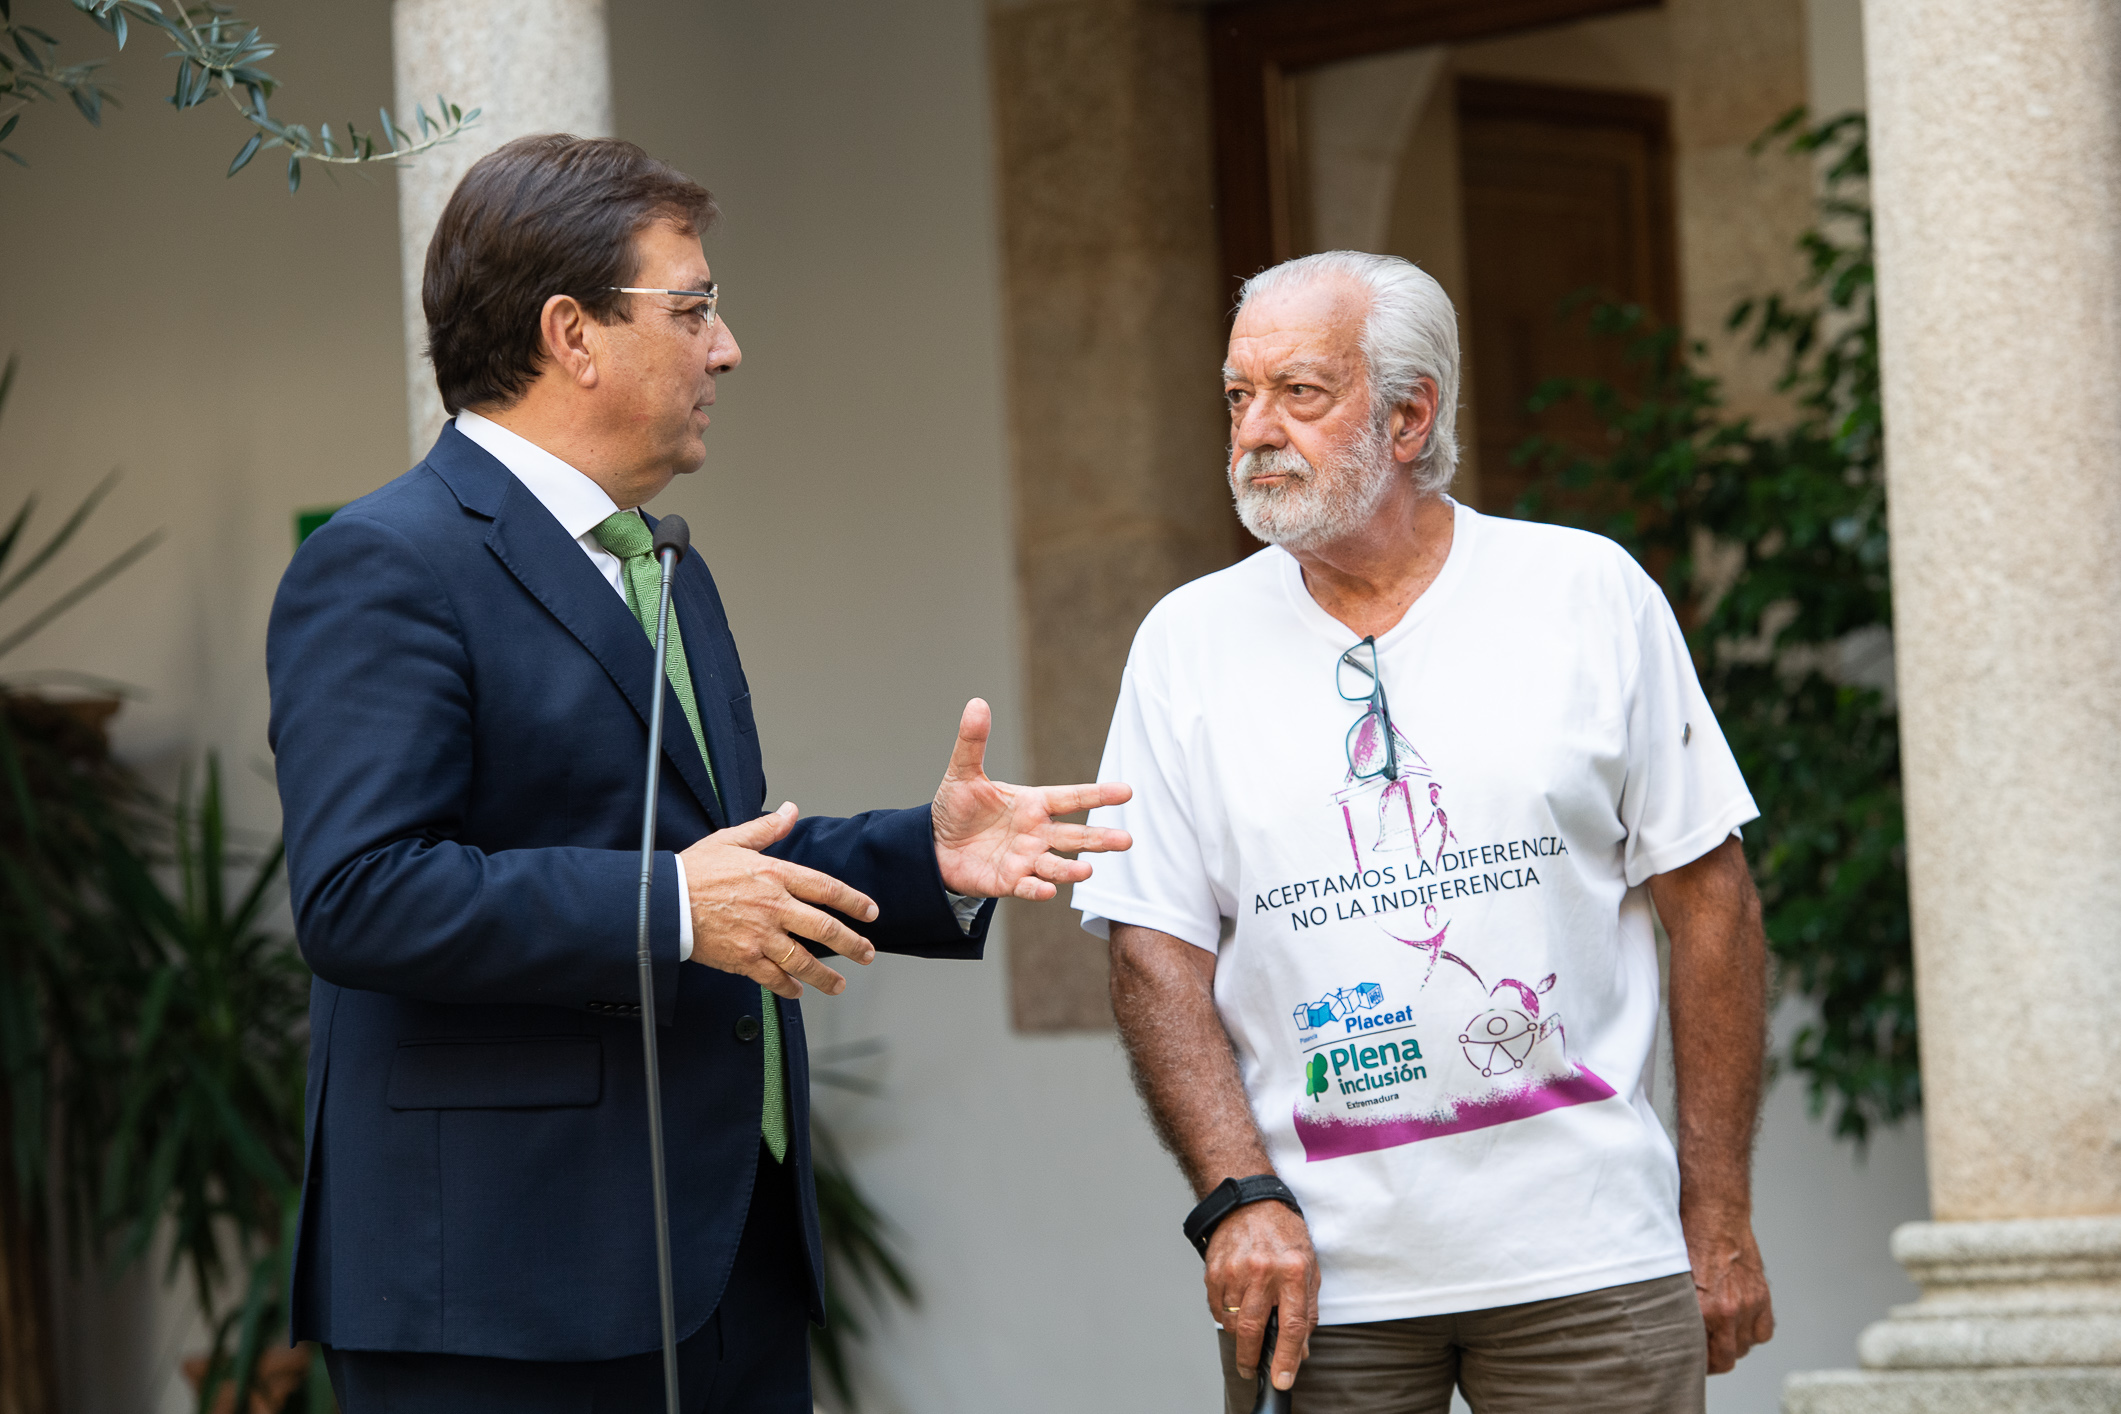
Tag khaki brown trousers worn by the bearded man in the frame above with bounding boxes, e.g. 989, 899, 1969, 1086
1222, 1272, 1710, 1414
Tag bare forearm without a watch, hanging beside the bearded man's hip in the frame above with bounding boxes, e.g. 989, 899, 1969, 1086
1650, 839, 1767, 1217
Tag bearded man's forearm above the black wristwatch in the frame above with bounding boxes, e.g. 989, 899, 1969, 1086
1111, 924, 1273, 1194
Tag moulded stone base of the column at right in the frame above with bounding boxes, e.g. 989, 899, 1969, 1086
1782, 1217, 2121, 1414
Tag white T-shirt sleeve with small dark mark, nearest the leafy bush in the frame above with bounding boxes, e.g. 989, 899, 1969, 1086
1620, 562, 1760, 888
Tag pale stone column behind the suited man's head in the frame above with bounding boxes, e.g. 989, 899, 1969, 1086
390, 0, 611, 460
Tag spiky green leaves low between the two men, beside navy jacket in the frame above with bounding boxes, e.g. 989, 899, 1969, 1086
810, 1041, 921, 1412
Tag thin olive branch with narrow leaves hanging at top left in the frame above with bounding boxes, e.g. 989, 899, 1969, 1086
0, 0, 479, 182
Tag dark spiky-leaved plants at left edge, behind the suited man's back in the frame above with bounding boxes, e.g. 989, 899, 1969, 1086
0, 358, 329, 1410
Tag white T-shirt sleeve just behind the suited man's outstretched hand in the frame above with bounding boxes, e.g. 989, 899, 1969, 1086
1069, 630, 1222, 952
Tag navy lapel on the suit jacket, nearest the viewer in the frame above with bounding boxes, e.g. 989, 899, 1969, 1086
477, 470, 728, 829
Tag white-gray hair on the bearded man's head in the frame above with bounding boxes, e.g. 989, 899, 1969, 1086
1237, 250, 1459, 496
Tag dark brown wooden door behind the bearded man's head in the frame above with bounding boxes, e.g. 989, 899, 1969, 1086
1457, 78, 1678, 515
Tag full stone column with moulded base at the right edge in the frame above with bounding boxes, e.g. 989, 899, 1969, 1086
1784, 0, 2121, 1414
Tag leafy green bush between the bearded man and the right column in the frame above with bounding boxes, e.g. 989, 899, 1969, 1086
1519, 110, 1922, 1143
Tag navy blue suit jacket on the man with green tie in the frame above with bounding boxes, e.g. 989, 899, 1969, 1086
267, 426, 993, 1361
